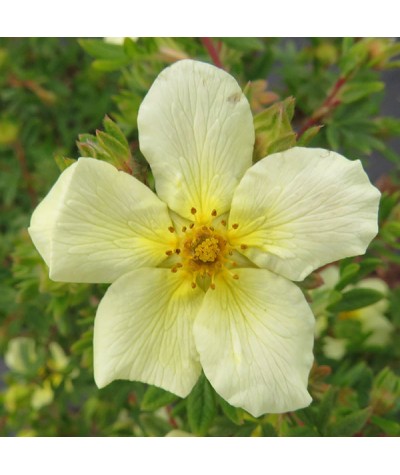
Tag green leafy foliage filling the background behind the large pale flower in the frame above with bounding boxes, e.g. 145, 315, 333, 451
0, 38, 400, 437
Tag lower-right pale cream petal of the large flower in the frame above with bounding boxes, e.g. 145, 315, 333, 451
194, 269, 314, 417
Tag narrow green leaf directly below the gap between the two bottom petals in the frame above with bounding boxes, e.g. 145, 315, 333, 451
186, 375, 216, 436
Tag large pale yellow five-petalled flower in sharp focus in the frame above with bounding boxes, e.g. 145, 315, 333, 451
29, 60, 380, 416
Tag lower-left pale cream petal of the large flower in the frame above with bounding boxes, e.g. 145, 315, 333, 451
94, 268, 204, 397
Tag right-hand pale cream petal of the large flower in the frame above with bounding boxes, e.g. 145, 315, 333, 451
230, 147, 380, 280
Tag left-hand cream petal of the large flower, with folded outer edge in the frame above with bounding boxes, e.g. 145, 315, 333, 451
29, 158, 176, 283
